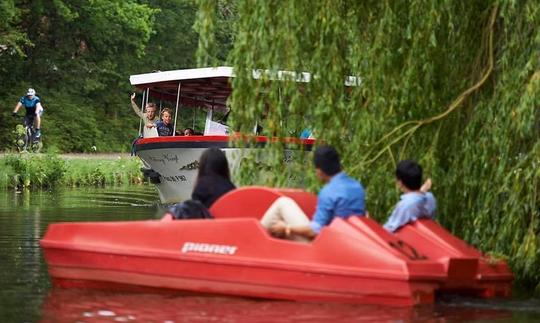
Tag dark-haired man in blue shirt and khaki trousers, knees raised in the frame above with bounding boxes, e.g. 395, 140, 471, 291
261, 146, 365, 241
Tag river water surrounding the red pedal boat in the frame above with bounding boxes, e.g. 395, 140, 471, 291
0, 186, 540, 323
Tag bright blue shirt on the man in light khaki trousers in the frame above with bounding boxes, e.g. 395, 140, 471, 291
311, 172, 365, 233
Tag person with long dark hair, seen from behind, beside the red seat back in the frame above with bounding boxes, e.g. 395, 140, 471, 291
191, 148, 236, 208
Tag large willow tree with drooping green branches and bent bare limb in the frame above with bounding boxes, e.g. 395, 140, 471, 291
197, 0, 540, 292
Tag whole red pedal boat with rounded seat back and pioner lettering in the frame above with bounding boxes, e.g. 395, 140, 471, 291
41, 187, 512, 305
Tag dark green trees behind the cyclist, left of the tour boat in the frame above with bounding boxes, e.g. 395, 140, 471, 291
0, 0, 207, 152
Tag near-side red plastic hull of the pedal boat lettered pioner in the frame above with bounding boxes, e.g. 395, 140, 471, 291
41, 218, 445, 305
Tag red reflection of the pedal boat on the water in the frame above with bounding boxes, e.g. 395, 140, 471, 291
42, 289, 524, 322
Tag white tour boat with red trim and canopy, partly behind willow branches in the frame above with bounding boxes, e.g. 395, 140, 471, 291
130, 67, 359, 203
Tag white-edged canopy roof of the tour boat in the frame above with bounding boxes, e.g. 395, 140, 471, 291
129, 66, 361, 109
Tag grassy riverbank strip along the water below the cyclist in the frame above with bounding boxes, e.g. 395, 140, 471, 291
0, 153, 144, 189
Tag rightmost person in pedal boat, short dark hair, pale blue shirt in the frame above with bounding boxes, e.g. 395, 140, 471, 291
384, 160, 437, 232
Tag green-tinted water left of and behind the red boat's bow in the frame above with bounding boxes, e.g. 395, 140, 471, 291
0, 186, 160, 322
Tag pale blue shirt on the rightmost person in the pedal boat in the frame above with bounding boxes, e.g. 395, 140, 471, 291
384, 192, 437, 232
